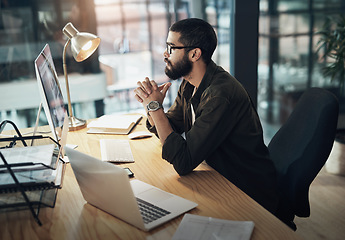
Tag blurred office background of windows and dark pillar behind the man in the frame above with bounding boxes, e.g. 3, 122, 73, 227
0, 0, 345, 141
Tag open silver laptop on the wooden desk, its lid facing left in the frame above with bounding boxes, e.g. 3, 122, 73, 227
65, 147, 198, 231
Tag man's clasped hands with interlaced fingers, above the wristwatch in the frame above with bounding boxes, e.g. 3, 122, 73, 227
134, 77, 171, 108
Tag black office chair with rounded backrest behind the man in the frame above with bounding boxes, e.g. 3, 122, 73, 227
268, 88, 339, 230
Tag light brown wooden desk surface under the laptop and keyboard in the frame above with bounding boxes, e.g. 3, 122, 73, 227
0, 120, 300, 240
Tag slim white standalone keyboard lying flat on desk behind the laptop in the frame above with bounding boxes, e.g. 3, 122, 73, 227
100, 139, 134, 163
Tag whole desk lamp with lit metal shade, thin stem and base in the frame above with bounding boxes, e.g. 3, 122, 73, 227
62, 23, 101, 131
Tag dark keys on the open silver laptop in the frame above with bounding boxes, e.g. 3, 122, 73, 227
136, 198, 170, 224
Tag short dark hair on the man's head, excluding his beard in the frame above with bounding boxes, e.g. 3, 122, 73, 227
169, 18, 217, 64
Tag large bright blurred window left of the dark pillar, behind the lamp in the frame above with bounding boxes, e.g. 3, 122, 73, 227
0, 0, 234, 127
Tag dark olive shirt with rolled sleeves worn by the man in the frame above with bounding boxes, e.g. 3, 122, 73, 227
148, 61, 278, 213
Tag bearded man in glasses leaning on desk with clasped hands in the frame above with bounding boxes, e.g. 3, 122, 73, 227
134, 19, 278, 213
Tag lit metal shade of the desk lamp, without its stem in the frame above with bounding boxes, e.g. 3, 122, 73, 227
62, 23, 101, 62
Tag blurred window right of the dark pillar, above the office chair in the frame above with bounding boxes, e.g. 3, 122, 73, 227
258, 0, 345, 130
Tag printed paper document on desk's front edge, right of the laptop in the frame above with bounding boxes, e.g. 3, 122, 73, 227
172, 214, 254, 240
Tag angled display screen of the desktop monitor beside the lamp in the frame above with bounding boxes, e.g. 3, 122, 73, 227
35, 44, 66, 141
